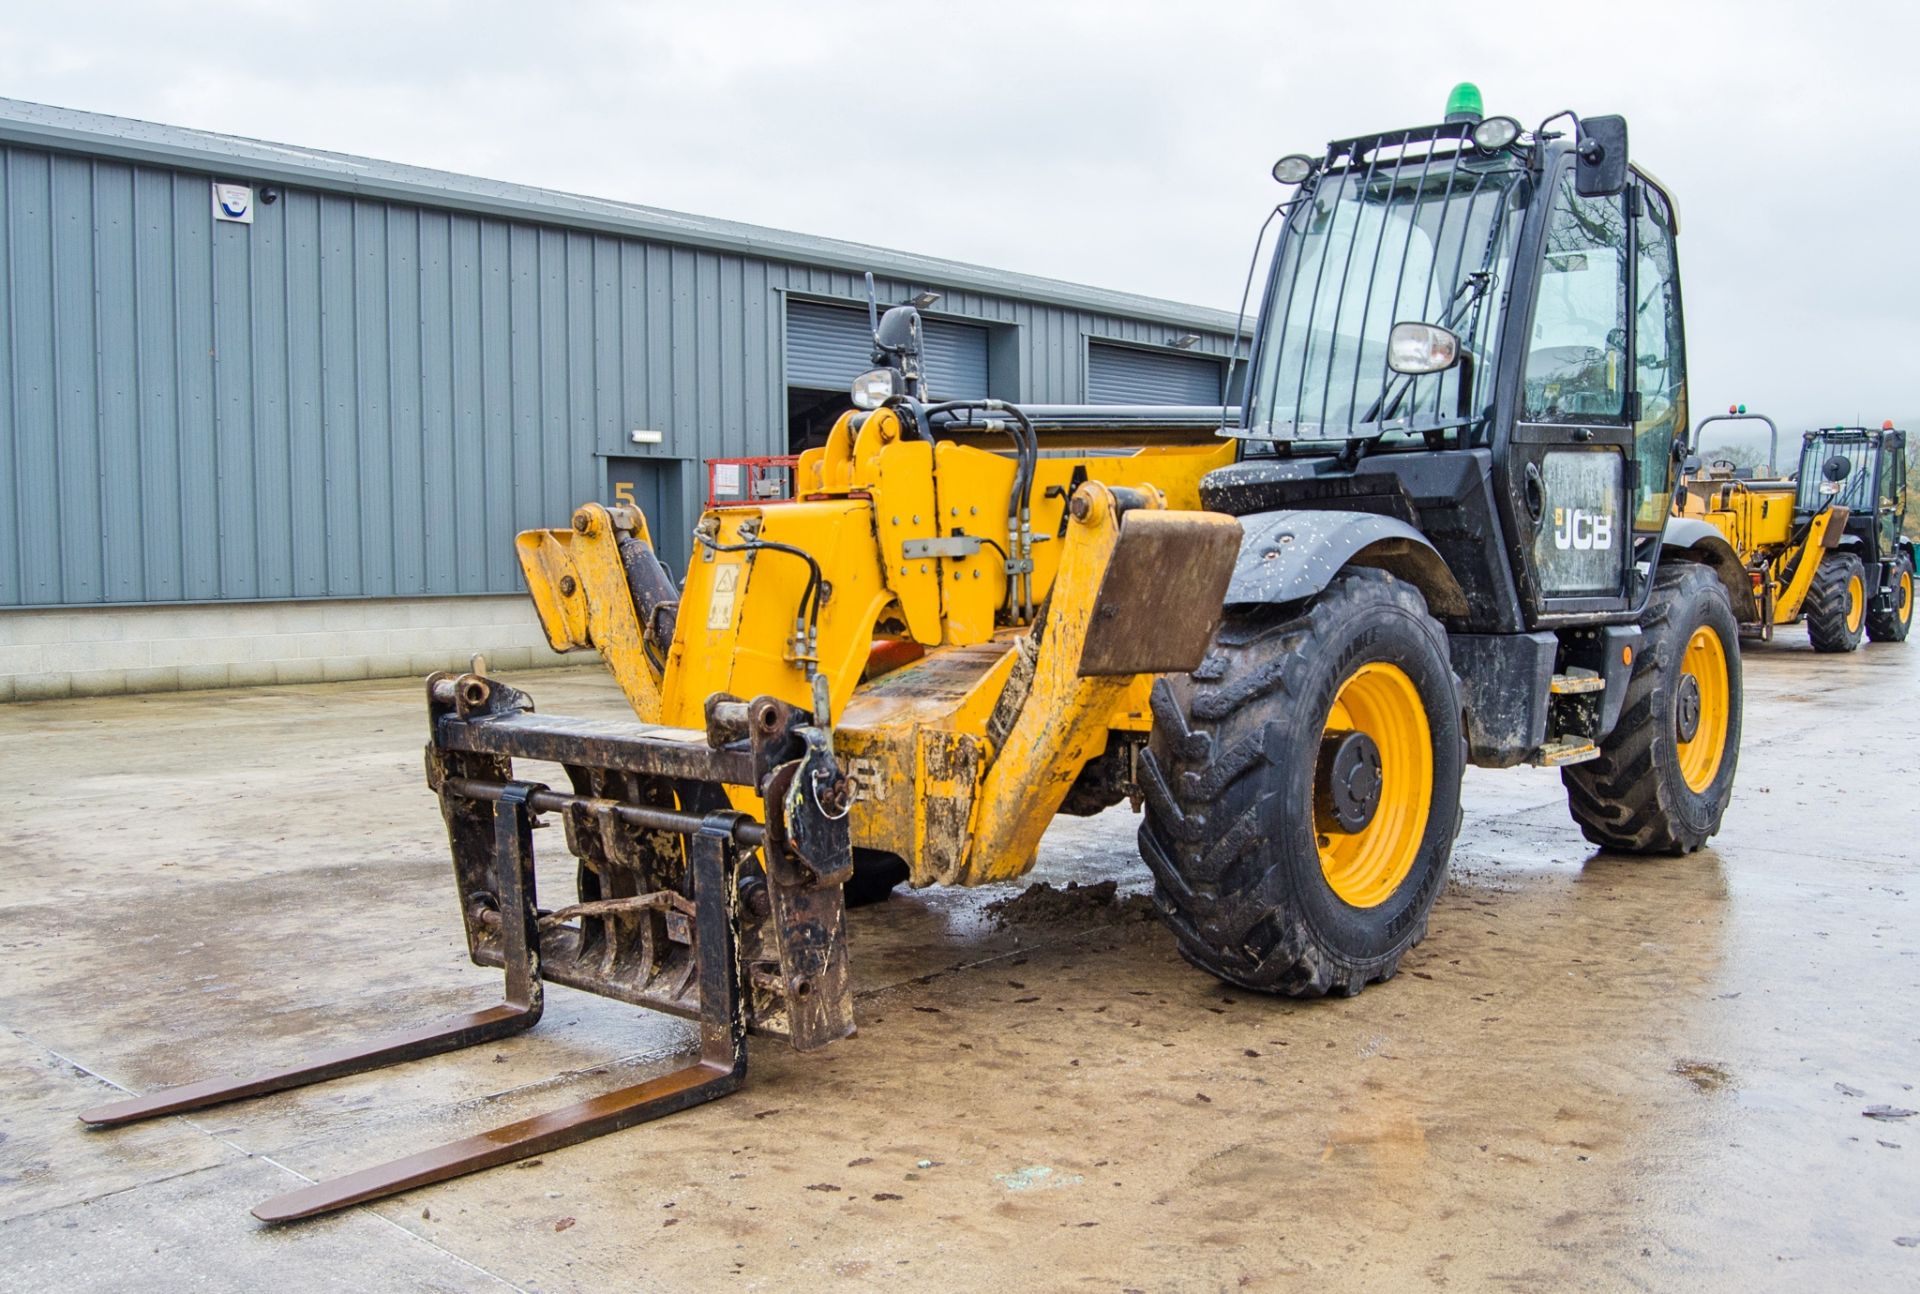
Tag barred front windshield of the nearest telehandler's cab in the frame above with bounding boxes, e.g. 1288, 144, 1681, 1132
1235, 140, 1523, 440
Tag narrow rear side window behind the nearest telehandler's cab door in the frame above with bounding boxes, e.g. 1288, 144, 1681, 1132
1634, 186, 1688, 532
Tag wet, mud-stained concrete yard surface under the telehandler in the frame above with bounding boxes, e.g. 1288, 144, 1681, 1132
0, 634, 1920, 1290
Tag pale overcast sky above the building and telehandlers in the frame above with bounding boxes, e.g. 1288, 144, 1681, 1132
0, 0, 1920, 428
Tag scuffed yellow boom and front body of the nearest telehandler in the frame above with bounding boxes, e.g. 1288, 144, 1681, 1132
518, 409, 1240, 885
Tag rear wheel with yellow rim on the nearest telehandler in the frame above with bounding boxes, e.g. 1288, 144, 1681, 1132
1561, 561, 1741, 854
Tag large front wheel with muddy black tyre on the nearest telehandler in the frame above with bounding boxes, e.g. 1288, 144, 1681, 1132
1140, 568, 1465, 998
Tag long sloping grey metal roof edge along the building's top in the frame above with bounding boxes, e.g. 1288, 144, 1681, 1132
0, 98, 1235, 334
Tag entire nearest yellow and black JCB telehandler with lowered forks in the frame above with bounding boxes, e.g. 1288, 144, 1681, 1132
84, 86, 1751, 1219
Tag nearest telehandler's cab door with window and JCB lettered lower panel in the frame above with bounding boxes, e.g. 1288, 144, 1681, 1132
1507, 165, 1638, 624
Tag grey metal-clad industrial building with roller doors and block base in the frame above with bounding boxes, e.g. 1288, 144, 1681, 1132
0, 100, 1235, 701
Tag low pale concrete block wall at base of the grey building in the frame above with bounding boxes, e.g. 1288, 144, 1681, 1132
0, 595, 576, 701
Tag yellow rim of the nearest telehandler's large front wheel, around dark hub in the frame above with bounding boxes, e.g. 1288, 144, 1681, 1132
1313, 660, 1434, 908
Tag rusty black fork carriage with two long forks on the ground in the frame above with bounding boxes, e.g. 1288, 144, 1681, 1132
81, 674, 852, 1221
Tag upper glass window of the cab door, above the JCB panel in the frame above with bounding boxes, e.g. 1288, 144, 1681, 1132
1523, 167, 1628, 422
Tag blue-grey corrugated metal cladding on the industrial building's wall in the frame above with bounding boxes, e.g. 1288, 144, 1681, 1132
0, 100, 1231, 607
